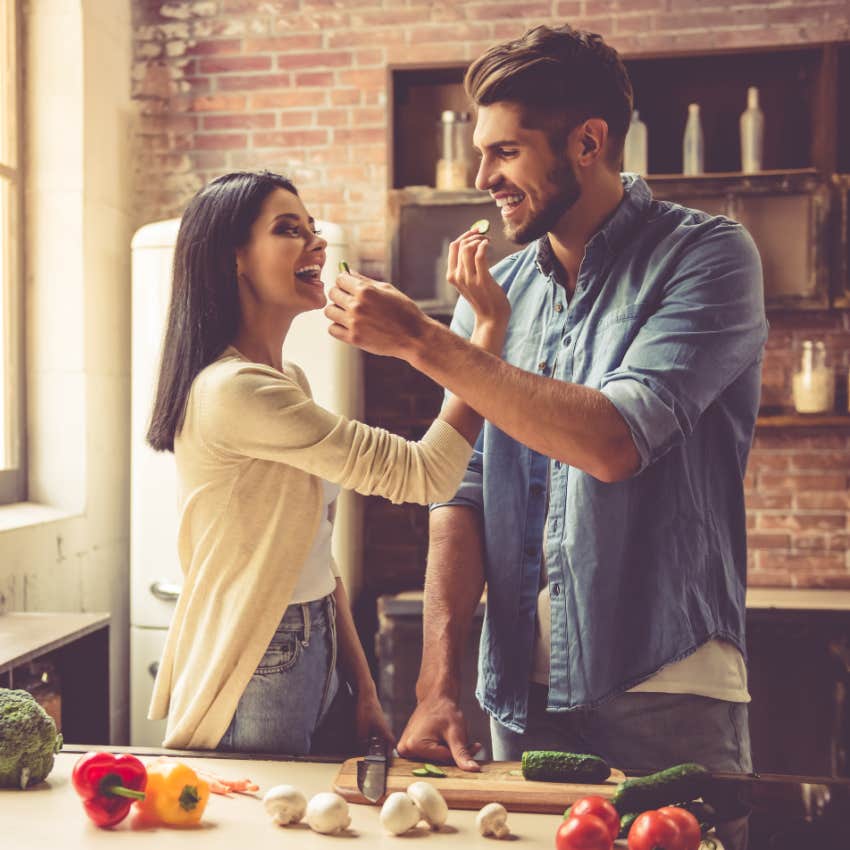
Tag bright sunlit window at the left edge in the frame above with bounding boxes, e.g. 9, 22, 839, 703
0, 0, 26, 503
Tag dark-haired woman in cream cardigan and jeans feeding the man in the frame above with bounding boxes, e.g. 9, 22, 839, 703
148, 172, 510, 755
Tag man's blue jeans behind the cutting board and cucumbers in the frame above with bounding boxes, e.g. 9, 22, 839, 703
490, 683, 753, 774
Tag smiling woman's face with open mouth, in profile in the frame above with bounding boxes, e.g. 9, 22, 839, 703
236, 189, 328, 316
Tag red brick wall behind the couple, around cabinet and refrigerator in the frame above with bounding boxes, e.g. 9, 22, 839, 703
132, 0, 850, 590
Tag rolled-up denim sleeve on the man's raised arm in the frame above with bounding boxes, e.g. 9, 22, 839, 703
599, 219, 767, 472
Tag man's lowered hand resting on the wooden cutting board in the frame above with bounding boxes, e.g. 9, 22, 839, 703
398, 696, 481, 771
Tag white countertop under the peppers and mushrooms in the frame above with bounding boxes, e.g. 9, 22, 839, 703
0, 752, 561, 850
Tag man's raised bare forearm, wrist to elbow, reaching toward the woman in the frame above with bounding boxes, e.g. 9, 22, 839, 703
407, 323, 639, 481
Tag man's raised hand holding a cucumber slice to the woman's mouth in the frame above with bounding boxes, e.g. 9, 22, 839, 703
325, 266, 433, 359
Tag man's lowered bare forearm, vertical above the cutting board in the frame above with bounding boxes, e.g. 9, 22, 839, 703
416, 506, 484, 701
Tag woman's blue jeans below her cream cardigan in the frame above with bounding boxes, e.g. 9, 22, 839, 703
217, 596, 339, 756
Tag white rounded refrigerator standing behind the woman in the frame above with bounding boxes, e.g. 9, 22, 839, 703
130, 219, 363, 747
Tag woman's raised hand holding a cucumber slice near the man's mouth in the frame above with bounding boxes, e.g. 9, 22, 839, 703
446, 230, 511, 353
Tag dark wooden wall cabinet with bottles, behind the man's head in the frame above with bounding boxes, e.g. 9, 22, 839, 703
388, 43, 850, 314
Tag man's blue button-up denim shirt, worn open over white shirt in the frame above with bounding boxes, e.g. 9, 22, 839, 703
432, 175, 767, 732
